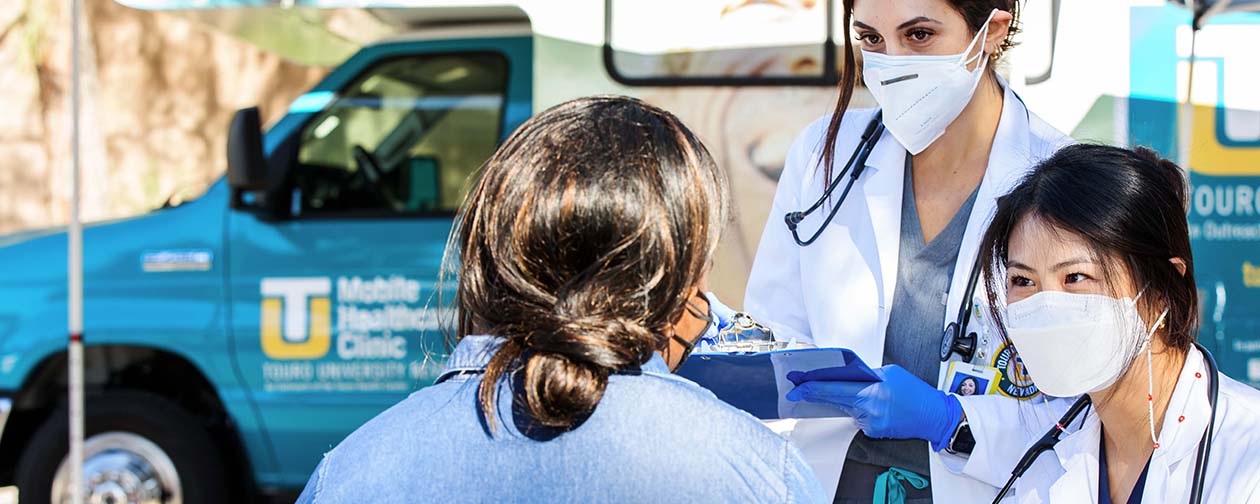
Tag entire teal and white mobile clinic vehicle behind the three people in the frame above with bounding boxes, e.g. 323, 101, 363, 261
0, 0, 1260, 503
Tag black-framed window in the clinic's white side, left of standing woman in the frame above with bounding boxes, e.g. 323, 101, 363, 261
604, 0, 845, 86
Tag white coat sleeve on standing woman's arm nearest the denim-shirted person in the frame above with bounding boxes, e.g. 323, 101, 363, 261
743, 117, 827, 344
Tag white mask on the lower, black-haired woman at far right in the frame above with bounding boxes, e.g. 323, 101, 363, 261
1005, 291, 1163, 397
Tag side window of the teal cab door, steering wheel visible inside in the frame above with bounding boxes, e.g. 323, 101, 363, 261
294, 53, 508, 215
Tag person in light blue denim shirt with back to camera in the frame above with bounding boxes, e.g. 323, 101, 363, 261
299, 97, 824, 503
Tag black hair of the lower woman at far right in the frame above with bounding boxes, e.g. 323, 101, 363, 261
980, 144, 1198, 357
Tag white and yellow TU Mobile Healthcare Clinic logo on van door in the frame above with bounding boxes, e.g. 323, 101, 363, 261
258, 273, 450, 393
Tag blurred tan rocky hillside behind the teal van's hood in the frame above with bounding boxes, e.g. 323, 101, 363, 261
0, 0, 326, 233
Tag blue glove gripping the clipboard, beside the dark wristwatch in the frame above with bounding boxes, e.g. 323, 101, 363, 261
788, 364, 963, 451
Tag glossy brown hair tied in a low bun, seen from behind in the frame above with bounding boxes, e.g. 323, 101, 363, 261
452, 97, 728, 430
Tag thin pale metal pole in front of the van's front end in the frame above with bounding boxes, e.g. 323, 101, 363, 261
67, 0, 83, 504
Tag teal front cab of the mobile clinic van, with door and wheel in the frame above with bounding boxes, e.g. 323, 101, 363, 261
0, 11, 533, 503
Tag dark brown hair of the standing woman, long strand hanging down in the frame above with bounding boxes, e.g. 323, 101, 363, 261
819, 0, 1019, 182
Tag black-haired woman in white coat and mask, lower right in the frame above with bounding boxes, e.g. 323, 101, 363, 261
969, 145, 1260, 503
